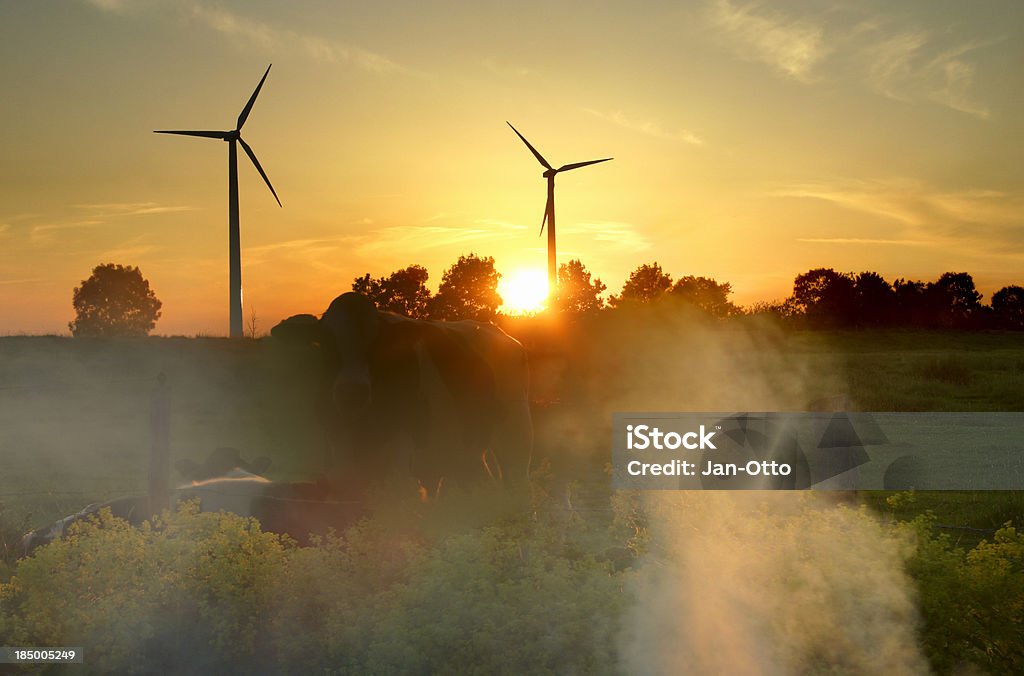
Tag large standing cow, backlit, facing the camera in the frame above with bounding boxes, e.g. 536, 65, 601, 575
316, 293, 532, 496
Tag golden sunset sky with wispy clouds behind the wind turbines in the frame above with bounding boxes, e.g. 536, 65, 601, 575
0, 0, 1024, 335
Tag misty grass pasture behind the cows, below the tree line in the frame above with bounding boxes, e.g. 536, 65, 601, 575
0, 320, 1024, 540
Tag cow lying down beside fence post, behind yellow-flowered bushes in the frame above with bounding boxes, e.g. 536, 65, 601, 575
22, 467, 362, 556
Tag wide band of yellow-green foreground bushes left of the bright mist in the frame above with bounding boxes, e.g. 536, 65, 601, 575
0, 496, 623, 673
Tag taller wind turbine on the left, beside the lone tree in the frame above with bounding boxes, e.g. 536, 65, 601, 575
153, 64, 282, 338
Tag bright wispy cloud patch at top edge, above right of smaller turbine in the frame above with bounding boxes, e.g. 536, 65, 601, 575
710, 0, 829, 82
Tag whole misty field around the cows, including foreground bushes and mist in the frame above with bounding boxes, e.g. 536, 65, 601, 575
0, 325, 1024, 674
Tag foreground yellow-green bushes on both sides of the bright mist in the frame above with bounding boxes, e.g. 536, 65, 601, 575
0, 493, 1024, 674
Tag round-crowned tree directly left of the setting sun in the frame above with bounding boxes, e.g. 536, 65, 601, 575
430, 253, 502, 322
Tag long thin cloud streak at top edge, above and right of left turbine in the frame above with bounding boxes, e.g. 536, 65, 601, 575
191, 3, 404, 73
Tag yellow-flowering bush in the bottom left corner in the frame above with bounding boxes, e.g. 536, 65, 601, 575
0, 504, 291, 673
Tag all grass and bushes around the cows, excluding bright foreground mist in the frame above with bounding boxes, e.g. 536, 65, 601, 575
0, 325, 1024, 673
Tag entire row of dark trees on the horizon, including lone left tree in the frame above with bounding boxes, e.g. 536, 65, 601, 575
69, 253, 1024, 336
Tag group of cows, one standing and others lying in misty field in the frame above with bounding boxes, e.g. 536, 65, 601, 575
23, 293, 532, 554
